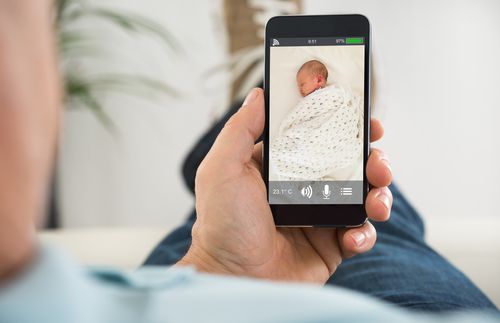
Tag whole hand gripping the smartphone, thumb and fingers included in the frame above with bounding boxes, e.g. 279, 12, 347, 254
178, 89, 392, 283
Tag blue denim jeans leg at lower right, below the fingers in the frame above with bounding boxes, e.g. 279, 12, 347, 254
328, 185, 496, 311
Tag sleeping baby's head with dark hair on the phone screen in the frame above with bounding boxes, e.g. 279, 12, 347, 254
297, 59, 328, 96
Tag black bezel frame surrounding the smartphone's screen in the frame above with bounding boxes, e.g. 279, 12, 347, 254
262, 14, 371, 227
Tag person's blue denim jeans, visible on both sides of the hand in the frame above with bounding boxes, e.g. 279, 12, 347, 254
145, 97, 497, 311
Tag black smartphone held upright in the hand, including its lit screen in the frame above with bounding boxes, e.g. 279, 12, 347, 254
263, 15, 370, 227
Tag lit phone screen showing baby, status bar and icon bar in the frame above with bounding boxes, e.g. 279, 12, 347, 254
268, 36, 365, 204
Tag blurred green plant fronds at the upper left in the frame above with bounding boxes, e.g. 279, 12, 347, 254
55, 0, 181, 132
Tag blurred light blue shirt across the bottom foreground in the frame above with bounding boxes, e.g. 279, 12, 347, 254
0, 246, 500, 323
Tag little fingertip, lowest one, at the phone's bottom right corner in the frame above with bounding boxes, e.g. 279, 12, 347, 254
337, 221, 377, 258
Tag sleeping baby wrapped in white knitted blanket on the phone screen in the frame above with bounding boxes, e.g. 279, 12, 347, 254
270, 60, 363, 180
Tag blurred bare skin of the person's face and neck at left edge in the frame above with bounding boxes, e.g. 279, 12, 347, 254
0, 0, 60, 281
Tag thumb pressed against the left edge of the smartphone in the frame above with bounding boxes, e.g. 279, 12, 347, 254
209, 88, 265, 165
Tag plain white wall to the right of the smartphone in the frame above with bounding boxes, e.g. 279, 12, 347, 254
305, 0, 500, 223
